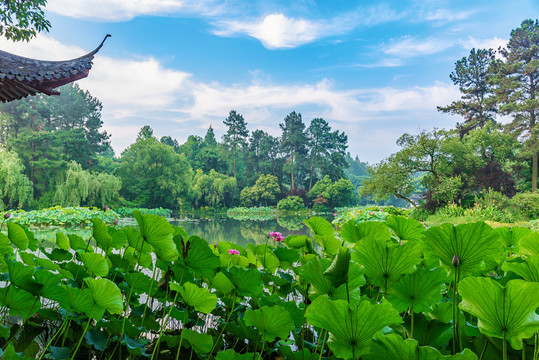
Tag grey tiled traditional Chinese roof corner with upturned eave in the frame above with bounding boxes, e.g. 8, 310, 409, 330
0, 35, 110, 102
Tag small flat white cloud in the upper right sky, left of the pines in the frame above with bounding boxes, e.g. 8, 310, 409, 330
383, 35, 454, 57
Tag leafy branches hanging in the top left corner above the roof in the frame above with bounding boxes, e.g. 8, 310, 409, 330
0, 0, 51, 41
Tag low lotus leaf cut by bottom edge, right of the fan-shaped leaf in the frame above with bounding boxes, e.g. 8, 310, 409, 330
362, 334, 477, 360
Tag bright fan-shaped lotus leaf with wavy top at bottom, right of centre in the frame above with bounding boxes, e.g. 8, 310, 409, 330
305, 296, 402, 359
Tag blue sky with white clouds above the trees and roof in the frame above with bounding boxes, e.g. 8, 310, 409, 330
0, 0, 539, 163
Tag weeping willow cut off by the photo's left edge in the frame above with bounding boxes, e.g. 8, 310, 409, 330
0, 150, 33, 210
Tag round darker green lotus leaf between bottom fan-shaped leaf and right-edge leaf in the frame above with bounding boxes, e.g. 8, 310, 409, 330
387, 268, 447, 313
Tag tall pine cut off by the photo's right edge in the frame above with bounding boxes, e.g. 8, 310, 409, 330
496, 19, 539, 191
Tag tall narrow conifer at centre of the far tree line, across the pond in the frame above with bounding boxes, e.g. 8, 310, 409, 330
279, 111, 309, 190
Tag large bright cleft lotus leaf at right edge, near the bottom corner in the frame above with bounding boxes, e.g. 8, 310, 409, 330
459, 277, 539, 349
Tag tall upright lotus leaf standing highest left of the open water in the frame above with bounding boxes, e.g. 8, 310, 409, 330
133, 210, 180, 261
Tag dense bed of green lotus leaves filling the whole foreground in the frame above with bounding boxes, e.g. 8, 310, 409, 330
0, 211, 539, 360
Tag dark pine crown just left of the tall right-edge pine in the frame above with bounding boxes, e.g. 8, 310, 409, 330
438, 49, 497, 135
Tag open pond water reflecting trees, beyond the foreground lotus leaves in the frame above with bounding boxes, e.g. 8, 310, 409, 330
32, 215, 333, 246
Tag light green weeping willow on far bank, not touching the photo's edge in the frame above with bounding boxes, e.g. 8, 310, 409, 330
54, 161, 122, 207
